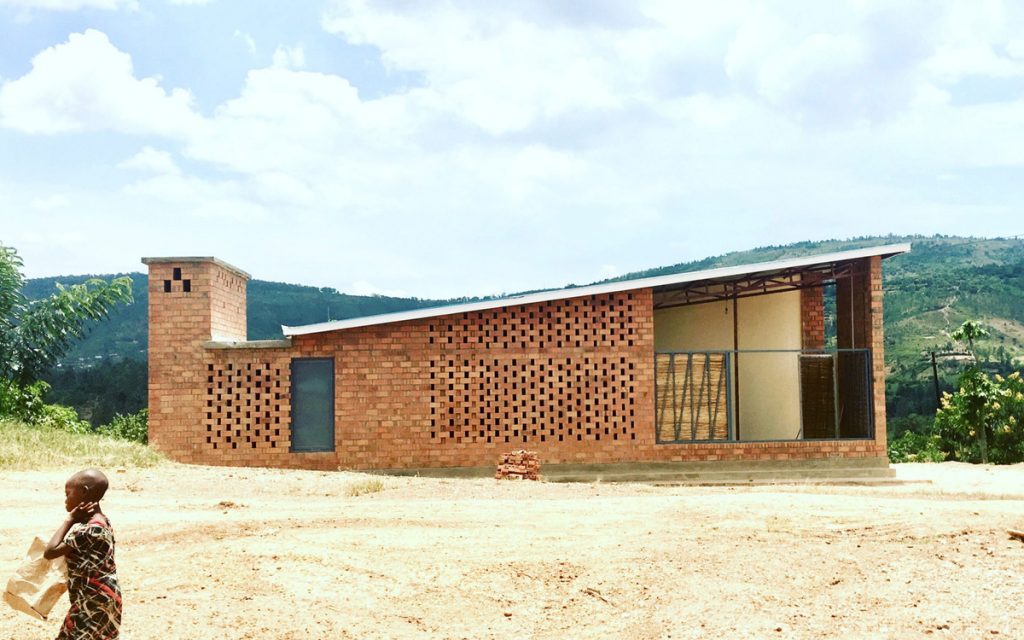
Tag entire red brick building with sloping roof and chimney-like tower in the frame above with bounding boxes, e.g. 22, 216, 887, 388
142, 245, 909, 471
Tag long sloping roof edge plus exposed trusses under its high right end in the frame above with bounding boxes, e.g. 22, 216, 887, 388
282, 243, 910, 336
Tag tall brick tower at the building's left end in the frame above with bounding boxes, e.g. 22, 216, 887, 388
142, 258, 249, 462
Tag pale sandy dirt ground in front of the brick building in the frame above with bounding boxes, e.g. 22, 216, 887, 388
0, 463, 1024, 640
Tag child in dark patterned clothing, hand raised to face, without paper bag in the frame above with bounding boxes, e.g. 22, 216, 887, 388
43, 469, 121, 640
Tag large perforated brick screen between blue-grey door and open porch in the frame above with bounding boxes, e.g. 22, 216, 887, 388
427, 293, 646, 445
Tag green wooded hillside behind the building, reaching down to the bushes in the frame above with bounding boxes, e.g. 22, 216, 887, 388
26, 237, 1024, 430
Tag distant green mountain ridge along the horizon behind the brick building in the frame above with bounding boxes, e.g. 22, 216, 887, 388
25, 236, 1024, 366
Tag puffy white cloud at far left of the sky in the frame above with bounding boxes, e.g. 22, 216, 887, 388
0, 29, 201, 136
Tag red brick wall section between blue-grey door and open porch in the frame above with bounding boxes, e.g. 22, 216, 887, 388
280, 291, 653, 468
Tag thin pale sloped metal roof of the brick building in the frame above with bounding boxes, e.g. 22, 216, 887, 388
281, 243, 910, 336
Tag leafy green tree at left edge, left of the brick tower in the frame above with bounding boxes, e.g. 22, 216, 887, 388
0, 245, 132, 392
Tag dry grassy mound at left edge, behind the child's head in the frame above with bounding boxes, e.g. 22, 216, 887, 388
0, 419, 166, 471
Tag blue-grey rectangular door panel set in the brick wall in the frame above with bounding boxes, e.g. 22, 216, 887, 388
292, 357, 334, 452
